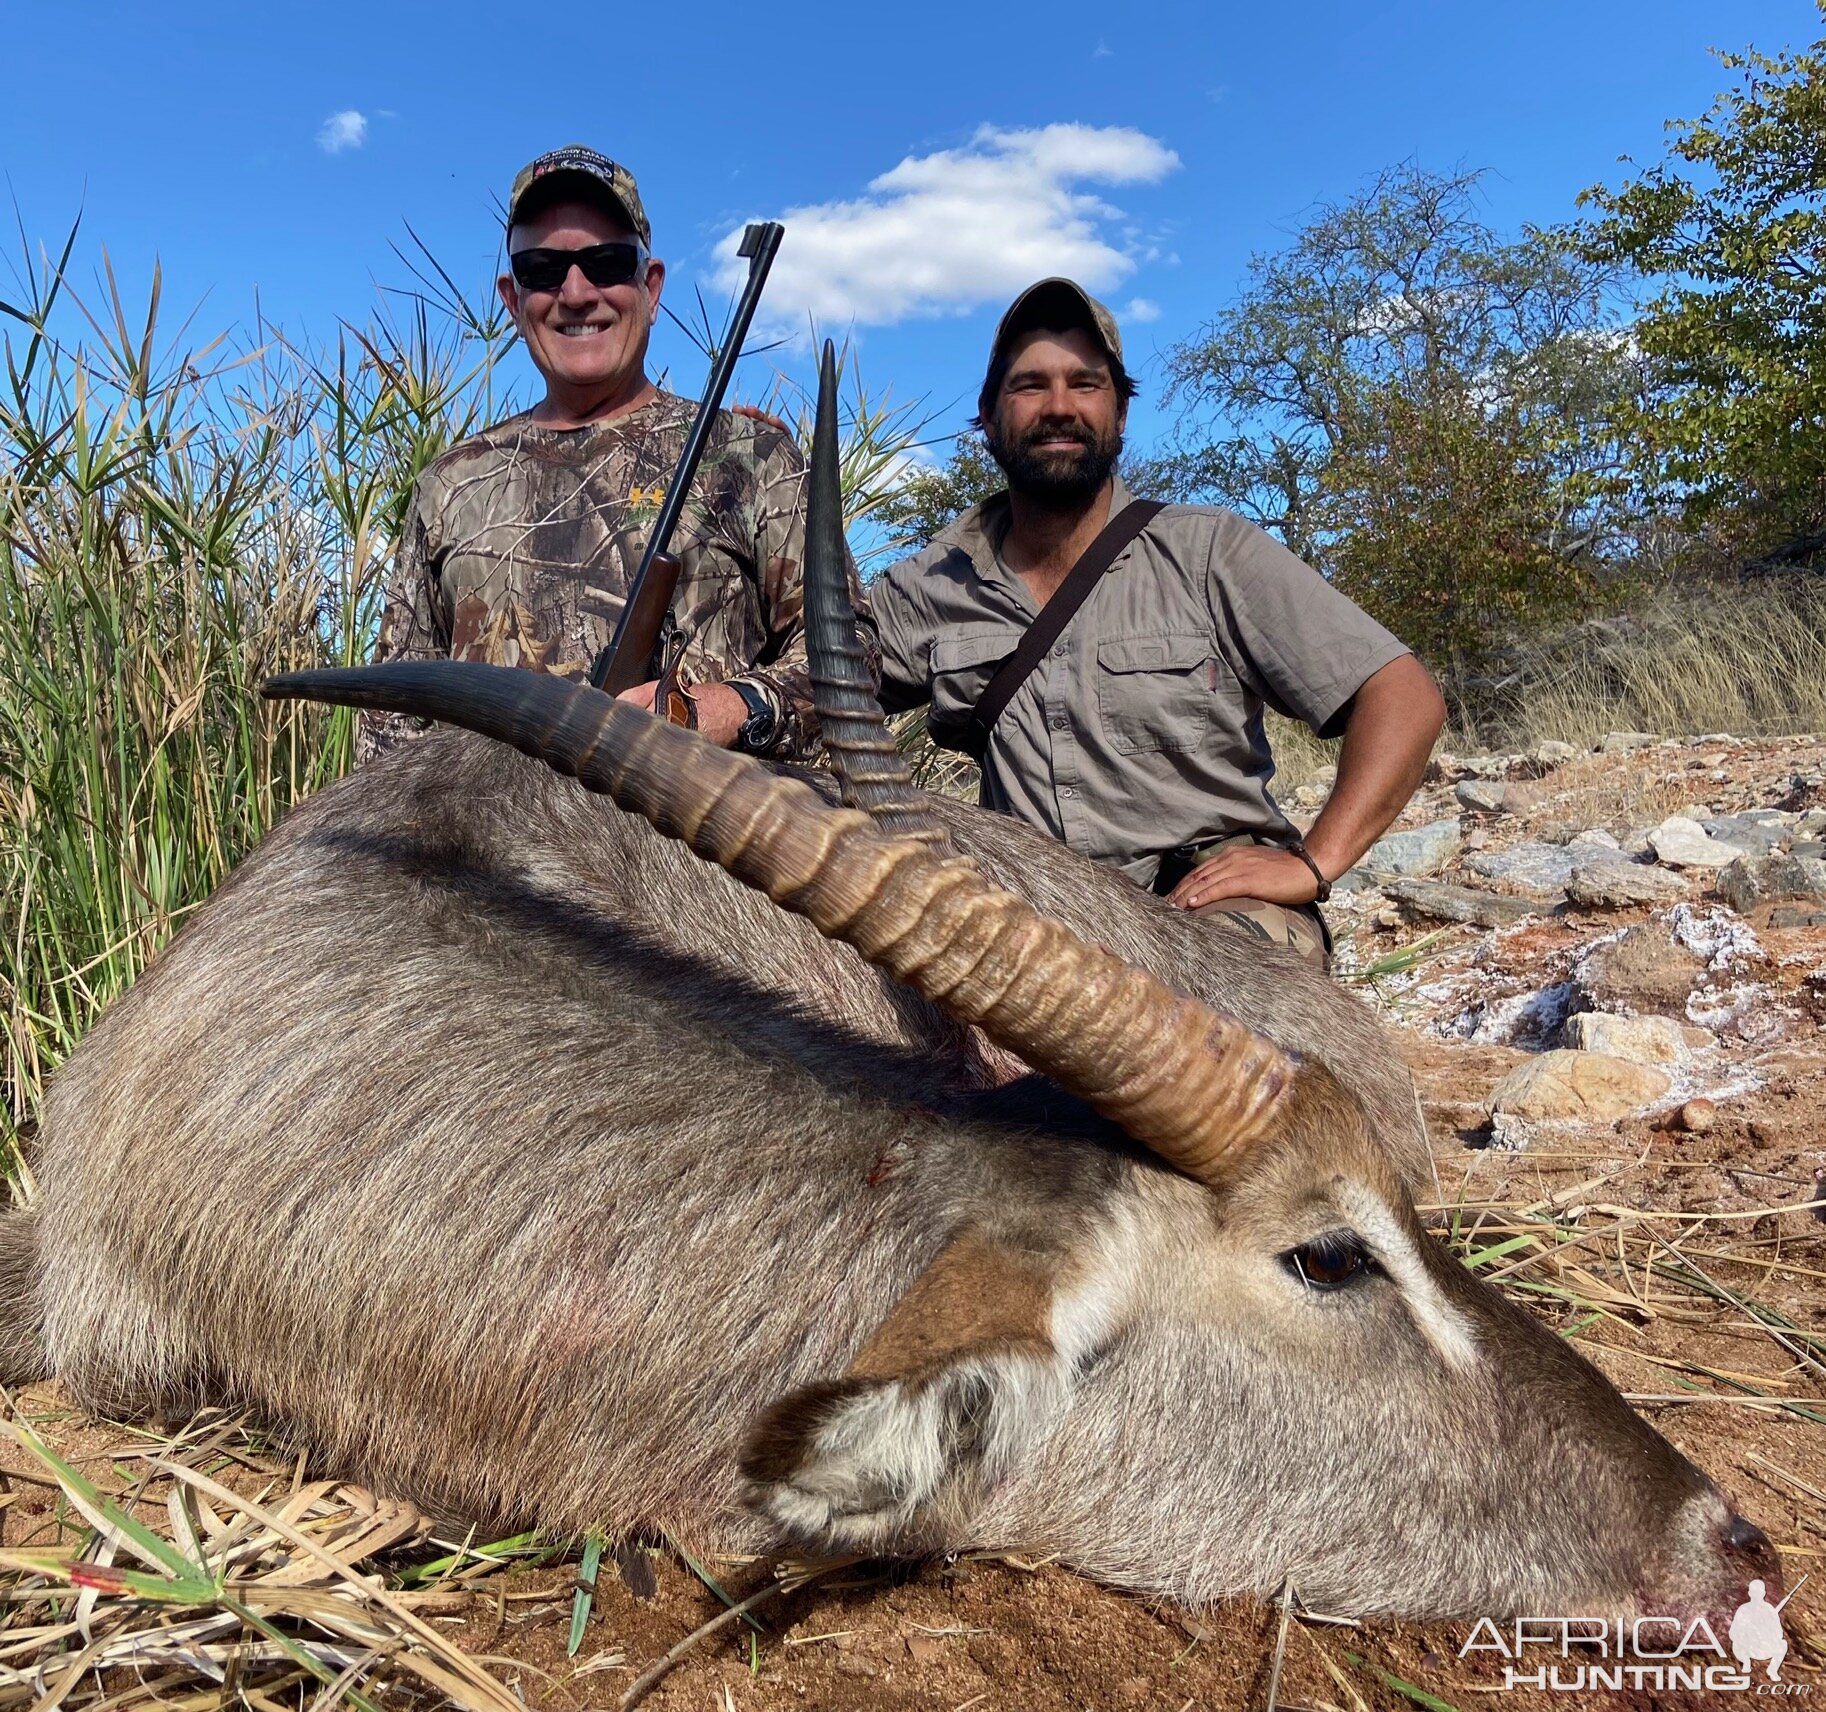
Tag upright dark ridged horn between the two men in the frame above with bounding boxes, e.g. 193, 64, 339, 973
805, 339, 951, 852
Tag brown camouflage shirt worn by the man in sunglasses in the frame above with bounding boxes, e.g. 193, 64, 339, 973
360, 392, 875, 761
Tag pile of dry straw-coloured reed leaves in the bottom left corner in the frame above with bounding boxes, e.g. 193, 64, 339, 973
0, 1409, 520, 1712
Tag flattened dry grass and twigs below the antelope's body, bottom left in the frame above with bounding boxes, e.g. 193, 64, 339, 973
0, 1391, 856, 1712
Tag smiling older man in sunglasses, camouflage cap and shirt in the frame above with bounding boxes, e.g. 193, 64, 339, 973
360, 146, 873, 759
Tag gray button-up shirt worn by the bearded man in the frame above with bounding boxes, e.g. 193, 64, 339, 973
869, 480, 1408, 885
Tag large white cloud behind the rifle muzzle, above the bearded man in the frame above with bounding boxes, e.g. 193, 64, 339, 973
716, 124, 1180, 327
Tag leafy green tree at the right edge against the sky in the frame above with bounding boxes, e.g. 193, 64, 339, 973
1581, 0, 1826, 558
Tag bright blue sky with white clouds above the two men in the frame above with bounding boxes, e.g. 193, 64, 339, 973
0, 0, 1822, 459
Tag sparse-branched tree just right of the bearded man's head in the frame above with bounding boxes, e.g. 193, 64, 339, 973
1149, 166, 1638, 659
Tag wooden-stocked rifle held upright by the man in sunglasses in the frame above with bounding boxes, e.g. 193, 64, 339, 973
590, 221, 787, 700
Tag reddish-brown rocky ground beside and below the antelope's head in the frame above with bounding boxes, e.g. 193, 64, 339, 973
0, 734, 1826, 1712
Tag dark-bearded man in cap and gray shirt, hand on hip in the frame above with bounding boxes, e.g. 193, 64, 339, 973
869, 279, 1446, 964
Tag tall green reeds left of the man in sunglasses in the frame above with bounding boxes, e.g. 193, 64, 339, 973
0, 228, 511, 1174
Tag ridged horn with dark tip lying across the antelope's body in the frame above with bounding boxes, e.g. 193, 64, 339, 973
261, 661, 1295, 1181
